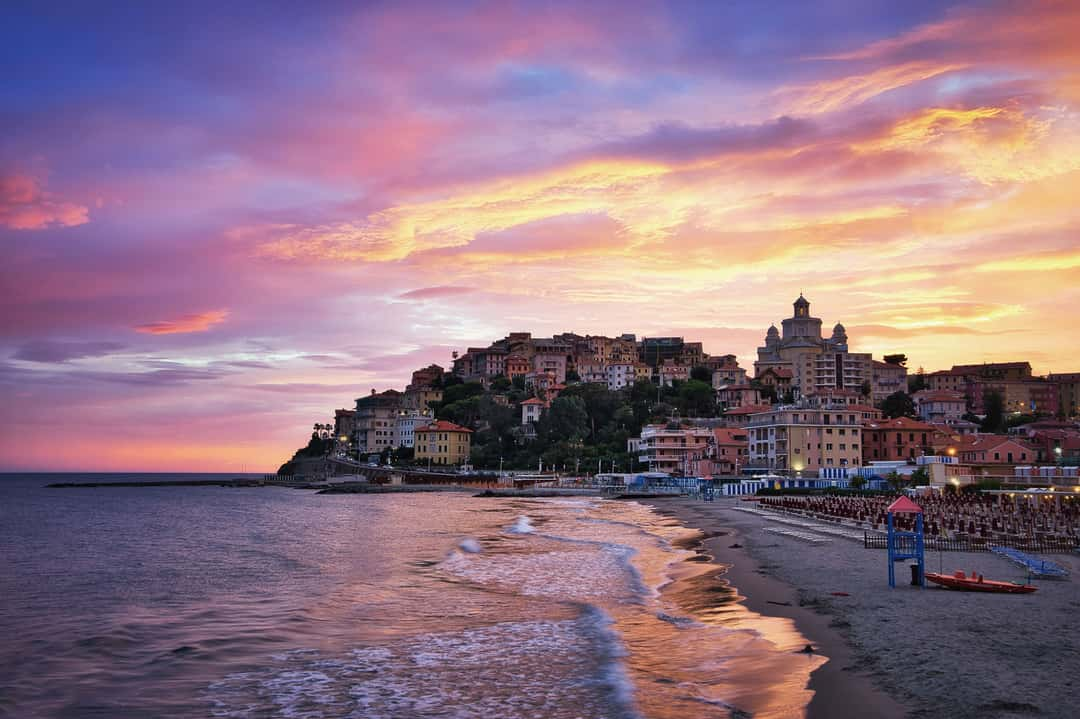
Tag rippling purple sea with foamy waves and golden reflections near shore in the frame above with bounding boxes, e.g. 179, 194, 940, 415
0, 474, 825, 719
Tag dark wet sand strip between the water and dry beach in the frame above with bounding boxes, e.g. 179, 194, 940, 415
637, 498, 906, 719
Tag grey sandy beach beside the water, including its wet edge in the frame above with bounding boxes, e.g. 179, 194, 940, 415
647, 498, 1080, 719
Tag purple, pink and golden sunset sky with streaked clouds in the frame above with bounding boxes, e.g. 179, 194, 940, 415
0, 0, 1080, 472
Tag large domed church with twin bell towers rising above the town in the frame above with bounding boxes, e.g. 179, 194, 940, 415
754, 294, 873, 402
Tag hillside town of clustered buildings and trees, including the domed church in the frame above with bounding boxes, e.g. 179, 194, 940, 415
287, 295, 1080, 487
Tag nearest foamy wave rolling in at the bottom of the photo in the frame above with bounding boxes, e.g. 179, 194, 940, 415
204, 607, 638, 719
